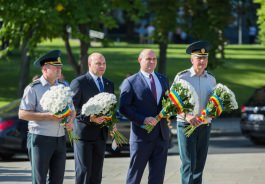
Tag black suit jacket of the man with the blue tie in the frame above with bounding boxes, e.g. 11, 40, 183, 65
70, 72, 114, 141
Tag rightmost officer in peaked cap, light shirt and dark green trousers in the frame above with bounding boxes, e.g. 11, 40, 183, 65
174, 41, 216, 184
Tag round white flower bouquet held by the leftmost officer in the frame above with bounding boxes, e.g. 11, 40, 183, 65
40, 85, 77, 145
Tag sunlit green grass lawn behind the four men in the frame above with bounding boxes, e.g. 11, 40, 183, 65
0, 40, 265, 113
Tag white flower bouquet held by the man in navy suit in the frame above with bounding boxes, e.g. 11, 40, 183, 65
143, 80, 199, 133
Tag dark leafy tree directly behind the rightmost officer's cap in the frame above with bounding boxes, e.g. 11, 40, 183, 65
182, 0, 232, 68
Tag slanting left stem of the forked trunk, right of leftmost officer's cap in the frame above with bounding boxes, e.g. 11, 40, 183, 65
63, 26, 80, 75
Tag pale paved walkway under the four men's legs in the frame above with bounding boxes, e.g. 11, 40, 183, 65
0, 153, 265, 184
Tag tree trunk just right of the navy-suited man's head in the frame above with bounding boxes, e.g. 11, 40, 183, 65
158, 42, 168, 75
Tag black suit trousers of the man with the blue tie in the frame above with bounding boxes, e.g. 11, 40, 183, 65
74, 140, 106, 184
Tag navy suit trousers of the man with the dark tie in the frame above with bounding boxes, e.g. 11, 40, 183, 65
126, 136, 168, 184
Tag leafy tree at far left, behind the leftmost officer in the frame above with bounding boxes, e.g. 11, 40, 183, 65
0, 0, 60, 96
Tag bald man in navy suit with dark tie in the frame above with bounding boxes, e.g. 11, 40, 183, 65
119, 49, 169, 184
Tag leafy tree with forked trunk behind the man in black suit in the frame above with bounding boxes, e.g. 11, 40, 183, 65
57, 0, 116, 74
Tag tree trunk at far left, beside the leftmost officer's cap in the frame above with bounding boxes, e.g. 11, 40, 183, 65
18, 38, 30, 98
